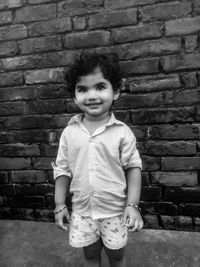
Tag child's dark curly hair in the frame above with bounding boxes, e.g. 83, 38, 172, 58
66, 53, 121, 96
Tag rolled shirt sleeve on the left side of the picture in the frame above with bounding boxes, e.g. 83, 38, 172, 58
51, 130, 72, 179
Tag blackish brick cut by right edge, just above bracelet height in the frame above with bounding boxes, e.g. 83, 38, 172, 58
164, 187, 200, 203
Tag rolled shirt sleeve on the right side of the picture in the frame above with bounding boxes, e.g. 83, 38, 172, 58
121, 126, 142, 169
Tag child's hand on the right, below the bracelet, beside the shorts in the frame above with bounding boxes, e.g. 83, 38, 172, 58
123, 207, 144, 232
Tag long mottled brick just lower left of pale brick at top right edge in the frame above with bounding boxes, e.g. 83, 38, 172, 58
112, 23, 162, 43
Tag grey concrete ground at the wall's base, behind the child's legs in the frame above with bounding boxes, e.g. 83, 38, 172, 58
0, 220, 200, 267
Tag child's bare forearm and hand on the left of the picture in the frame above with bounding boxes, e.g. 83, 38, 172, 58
54, 175, 71, 230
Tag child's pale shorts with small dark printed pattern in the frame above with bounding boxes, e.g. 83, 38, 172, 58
69, 213, 128, 249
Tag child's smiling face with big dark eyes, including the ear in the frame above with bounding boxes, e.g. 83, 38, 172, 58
74, 68, 119, 119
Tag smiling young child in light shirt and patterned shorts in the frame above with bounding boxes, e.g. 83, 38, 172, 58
53, 54, 143, 267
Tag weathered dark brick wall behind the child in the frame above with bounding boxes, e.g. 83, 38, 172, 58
0, 0, 200, 231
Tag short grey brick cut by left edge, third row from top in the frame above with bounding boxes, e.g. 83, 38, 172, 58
0, 24, 28, 41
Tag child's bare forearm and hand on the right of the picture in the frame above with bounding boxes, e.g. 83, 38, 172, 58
123, 168, 144, 231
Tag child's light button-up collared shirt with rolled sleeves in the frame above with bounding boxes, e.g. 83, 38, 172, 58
53, 113, 142, 219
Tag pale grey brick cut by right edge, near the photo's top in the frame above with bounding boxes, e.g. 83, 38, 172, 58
165, 17, 200, 36
